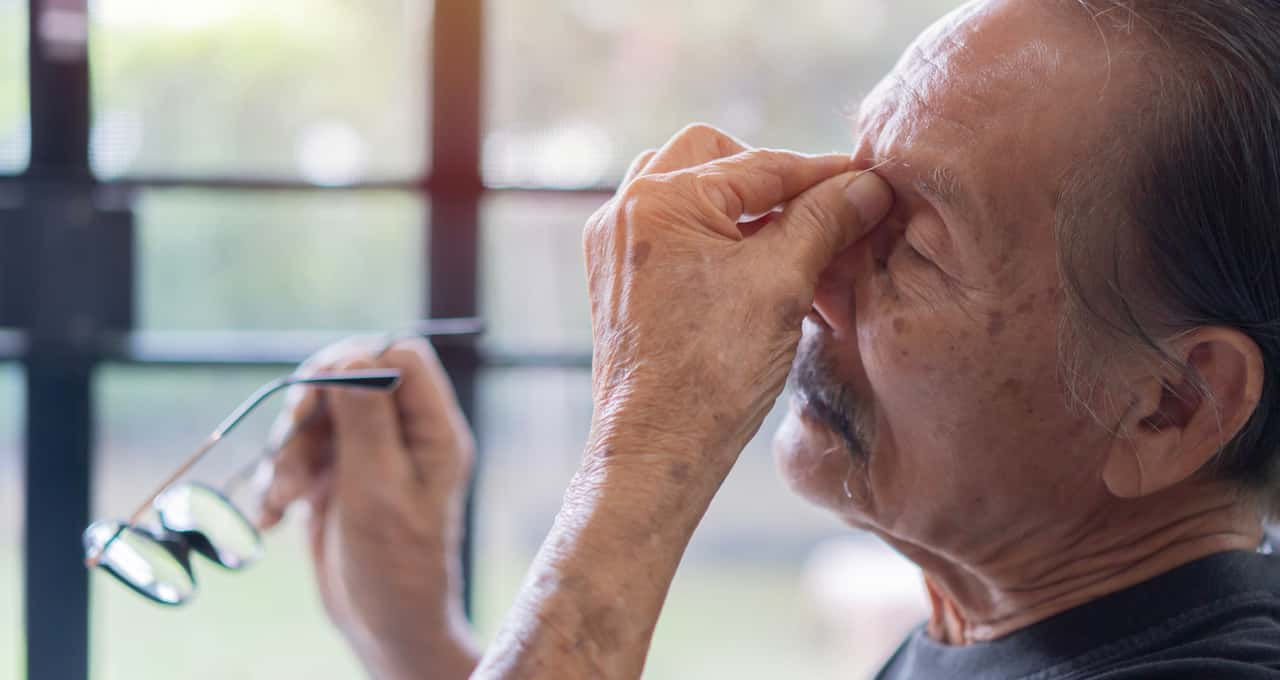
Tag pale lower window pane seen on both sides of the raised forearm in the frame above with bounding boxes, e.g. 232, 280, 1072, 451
476, 369, 924, 680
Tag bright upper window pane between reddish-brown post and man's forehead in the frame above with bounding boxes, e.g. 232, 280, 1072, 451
484, 0, 961, 187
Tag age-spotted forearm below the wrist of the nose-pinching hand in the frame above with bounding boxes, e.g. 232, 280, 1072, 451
472, 432, 723, 679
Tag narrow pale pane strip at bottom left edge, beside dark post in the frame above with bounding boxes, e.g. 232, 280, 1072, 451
0, 362, 27, 679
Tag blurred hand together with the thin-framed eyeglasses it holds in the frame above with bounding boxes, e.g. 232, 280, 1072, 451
83, 319, 480, 677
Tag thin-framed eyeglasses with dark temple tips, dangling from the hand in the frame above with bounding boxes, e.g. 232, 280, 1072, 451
81, 319, 481, 606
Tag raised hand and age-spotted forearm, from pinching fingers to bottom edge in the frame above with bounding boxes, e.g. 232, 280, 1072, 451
475, 125, 892, 679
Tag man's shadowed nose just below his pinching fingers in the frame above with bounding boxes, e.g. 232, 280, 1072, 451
813, 222, 895, 337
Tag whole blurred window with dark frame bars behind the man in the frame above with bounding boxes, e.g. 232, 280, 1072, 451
0, 0, 959, 680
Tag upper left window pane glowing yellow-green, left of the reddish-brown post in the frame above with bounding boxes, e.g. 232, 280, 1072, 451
90, 0, 431, 186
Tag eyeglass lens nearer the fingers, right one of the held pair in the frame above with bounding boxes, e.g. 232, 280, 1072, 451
155, 483, 262, 570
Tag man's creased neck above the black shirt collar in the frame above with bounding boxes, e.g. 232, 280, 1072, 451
886, 489, 1262, 644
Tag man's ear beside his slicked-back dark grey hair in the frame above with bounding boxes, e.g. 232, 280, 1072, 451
1102, 327, 1263, 498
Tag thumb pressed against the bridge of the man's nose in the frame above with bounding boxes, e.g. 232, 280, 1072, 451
762, 172, 893, 275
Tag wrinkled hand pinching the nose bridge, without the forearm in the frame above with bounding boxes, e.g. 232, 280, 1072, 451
584, 125, 892, 473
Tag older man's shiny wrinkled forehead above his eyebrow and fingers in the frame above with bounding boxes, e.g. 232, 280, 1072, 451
855, 0, 1115, 271
